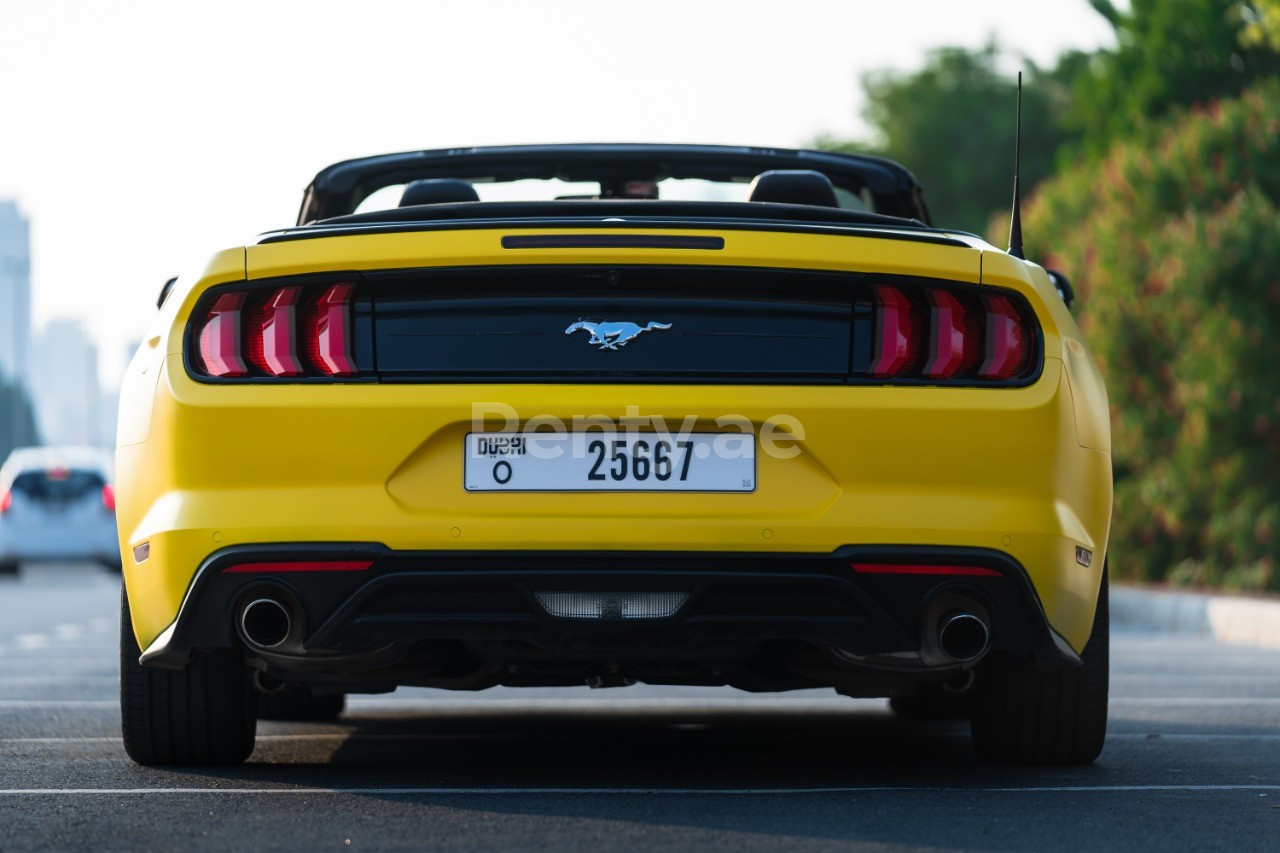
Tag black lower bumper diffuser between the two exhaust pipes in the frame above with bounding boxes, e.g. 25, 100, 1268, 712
142, 543, 1079, 689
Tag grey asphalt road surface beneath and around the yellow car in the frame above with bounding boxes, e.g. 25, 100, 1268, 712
0, 566, 1280, 853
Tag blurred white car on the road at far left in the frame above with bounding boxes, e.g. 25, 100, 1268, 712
0, 447, 120, 574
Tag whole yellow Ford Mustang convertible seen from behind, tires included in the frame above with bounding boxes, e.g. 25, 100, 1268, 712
116, 145, 1111, 763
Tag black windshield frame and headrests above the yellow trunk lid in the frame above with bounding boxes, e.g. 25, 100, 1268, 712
298, 143, 929, 225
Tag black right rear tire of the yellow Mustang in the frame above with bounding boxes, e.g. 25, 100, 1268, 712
973, 569, 1111, 765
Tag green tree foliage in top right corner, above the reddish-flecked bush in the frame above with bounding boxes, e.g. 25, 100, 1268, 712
1066, 0, 1280, 155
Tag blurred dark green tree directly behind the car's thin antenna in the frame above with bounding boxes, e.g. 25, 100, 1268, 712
815, 45, 1066, 232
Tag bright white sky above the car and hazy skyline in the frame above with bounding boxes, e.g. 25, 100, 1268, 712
0, 0, 1112, 384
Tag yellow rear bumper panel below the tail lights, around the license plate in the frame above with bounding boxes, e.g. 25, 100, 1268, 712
116, 356, 1111, 651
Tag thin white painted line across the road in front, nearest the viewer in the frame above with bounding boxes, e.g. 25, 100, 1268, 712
0, 785, 1280, 797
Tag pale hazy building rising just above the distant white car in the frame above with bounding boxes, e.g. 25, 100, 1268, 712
29, 320, 105, 447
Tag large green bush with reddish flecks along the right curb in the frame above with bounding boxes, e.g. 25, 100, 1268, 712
1025, 81, 1280, 589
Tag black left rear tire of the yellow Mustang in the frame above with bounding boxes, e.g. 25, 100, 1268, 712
120, 593, 257, 765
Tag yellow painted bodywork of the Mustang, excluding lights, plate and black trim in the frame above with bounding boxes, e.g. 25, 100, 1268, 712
116, 146, 1111, 760
